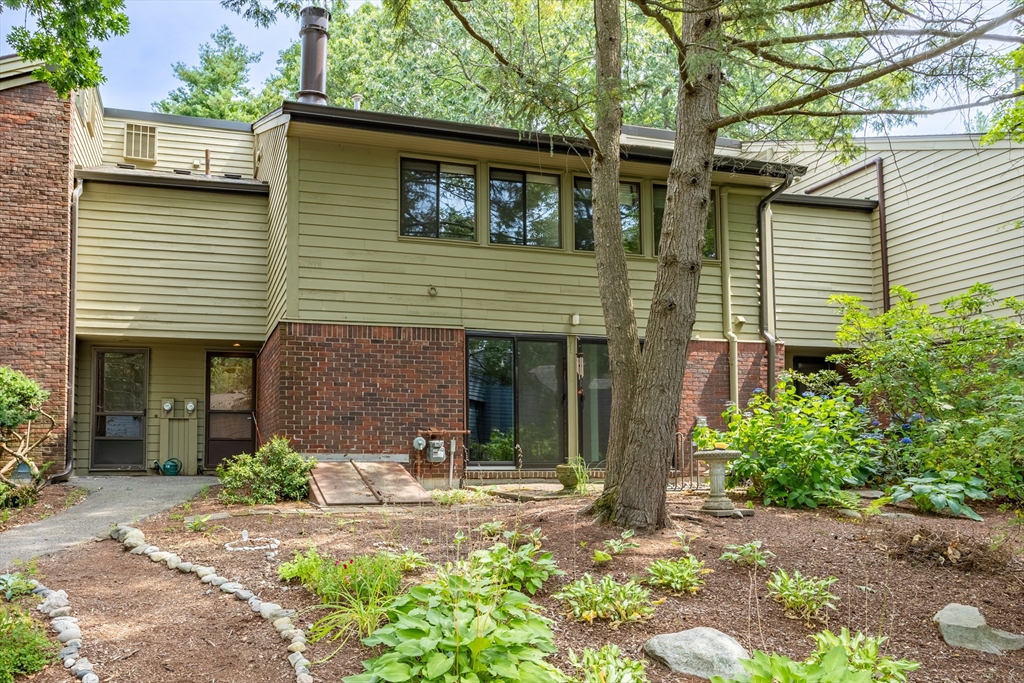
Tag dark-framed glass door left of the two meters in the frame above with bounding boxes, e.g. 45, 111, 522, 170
89, 349, 150, 471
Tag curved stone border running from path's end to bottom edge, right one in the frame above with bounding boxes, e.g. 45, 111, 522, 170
110, 523, 313, 683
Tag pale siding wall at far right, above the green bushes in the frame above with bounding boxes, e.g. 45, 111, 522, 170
794, 135, 1024, 312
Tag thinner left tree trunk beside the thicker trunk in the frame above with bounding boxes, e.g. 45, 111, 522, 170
591, 0, 640, 492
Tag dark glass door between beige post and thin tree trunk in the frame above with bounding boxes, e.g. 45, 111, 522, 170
578, 341, 611, 468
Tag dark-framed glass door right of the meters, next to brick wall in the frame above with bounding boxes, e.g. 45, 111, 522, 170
204, 353, 256, 469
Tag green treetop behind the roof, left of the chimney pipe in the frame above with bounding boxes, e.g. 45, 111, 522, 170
153, 26, 262, 121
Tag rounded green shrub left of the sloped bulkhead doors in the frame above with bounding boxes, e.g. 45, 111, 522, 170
217, 436, 316, 505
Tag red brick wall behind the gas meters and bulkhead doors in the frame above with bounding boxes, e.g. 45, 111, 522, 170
259, 323, 466, 477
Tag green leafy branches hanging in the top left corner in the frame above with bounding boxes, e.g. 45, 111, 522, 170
0, 0, 128, 97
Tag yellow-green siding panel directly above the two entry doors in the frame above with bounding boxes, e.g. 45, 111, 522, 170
75, 181, 266, 341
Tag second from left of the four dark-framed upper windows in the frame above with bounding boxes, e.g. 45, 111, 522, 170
490, 169, 562, 248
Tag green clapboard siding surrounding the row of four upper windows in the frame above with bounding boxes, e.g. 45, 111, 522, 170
289, 138, 758, 338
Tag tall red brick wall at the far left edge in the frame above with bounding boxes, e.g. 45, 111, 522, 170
0, 78, 73, 464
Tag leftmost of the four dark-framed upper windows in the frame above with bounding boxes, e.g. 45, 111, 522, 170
401, 159, 476, 240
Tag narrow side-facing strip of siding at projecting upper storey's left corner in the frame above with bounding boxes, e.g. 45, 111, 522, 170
256, 125, 289, 334
